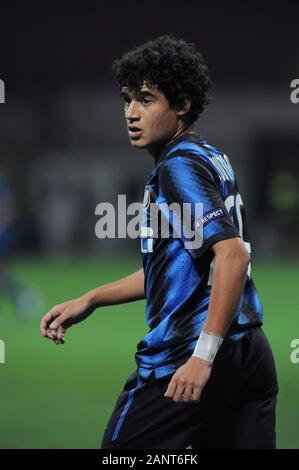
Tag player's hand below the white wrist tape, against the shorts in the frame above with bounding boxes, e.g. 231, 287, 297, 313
164, 356, 212, 403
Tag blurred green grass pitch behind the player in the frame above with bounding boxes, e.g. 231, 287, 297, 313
0, 259, 299, 448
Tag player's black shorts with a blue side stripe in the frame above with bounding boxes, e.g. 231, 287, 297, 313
101, 328, 278, 450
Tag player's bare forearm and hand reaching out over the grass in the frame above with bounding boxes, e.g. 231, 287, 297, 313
40, 269, 145, 344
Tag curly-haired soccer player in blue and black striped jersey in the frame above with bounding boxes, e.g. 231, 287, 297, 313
41, 36, 278, 449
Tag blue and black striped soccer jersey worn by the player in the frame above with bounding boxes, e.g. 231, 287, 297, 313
135, 134, 263, 378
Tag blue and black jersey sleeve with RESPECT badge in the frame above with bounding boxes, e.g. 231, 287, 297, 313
159, 155, 239, 258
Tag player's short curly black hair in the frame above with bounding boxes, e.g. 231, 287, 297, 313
112, 35, 212, 124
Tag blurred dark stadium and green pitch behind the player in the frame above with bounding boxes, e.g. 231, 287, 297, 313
0, 1, 299, 448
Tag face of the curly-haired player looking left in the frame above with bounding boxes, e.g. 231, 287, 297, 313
121, 82, 182, 148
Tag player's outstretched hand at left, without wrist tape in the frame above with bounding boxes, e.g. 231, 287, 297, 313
40, 296, 94, 344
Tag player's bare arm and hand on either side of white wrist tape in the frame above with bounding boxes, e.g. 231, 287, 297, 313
165, 238, 250, 402
